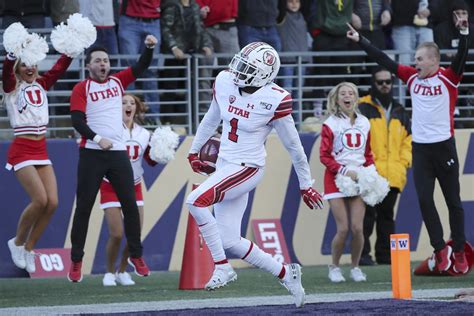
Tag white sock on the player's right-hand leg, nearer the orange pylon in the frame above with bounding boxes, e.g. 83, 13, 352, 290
227, 238, 283, 277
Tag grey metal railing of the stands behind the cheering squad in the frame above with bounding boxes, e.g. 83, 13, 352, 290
0, 51, 474, 138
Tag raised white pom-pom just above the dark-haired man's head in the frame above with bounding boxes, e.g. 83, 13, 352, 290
51, 13, 97, 57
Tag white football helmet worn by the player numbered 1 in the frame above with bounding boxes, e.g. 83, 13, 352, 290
229, 42, 280, 88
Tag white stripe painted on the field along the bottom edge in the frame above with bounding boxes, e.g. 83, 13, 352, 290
0, 289, 466, 316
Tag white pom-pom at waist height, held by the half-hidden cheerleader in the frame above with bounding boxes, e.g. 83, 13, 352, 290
150, 126, 179, 164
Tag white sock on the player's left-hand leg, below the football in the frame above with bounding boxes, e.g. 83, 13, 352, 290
188, 204, 227, 262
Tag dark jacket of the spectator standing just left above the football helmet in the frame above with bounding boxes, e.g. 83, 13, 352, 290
160, 0, 212, 53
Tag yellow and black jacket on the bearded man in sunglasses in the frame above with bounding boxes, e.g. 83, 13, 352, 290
359, 94, 412, 192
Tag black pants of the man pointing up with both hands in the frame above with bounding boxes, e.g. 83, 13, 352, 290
413, 137, 466, 251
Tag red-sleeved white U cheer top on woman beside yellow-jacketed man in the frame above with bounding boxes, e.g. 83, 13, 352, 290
320, 113, 370, 171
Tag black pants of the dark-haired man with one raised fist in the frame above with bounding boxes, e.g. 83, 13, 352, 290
71, 148, 142, 262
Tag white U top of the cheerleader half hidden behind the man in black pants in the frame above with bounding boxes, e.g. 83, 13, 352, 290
123, 123, 150, 184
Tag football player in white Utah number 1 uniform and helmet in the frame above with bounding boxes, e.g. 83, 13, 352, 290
186, 42, 323, 307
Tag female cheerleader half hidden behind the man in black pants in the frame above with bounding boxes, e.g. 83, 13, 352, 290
100, 94, 156, 286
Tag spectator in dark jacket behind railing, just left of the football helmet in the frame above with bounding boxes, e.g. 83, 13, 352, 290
161, 0, 213, 119
